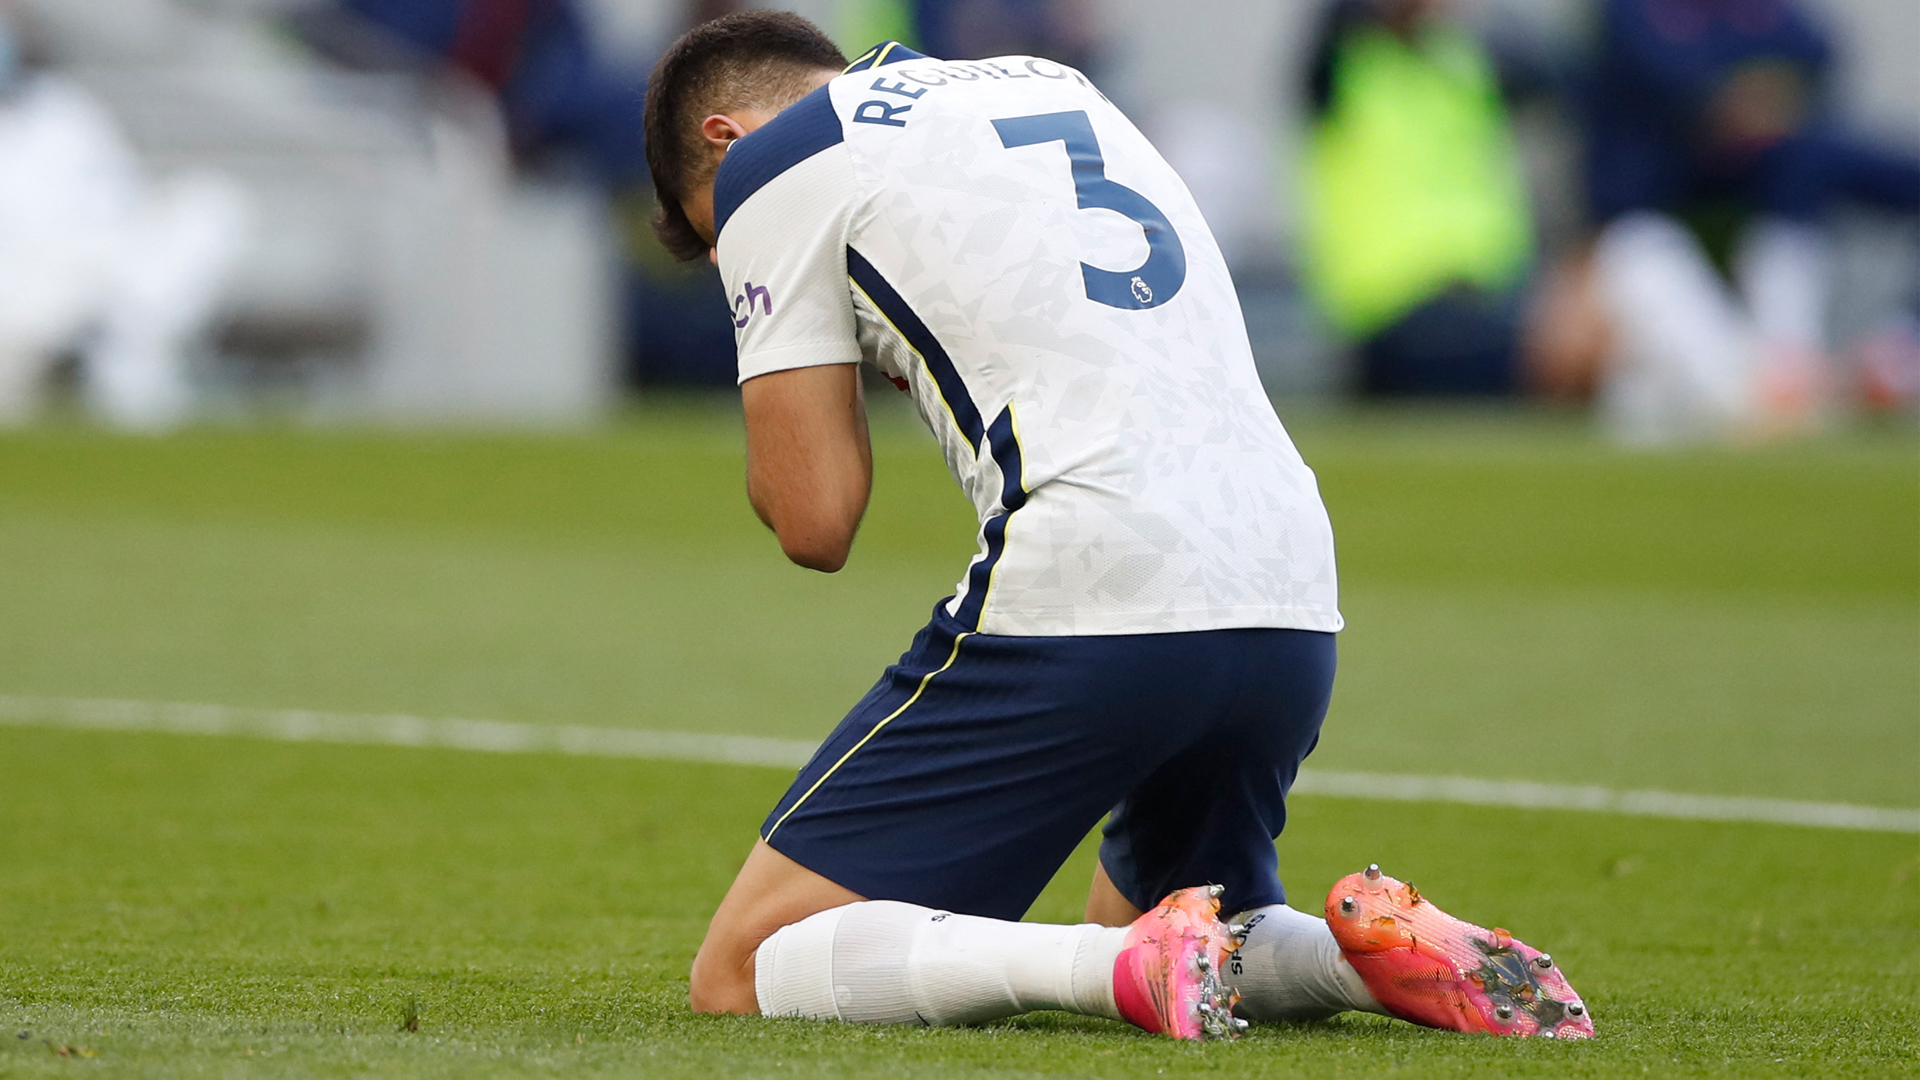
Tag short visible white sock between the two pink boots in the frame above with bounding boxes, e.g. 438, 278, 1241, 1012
1227, 903, 1386, 1020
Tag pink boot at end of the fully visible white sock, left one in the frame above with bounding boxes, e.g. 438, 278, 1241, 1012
1114, 886, 1246, 1040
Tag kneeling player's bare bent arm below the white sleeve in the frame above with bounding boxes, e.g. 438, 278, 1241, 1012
739, 363, 874, 573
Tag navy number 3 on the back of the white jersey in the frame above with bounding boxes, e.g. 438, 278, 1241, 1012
993, 110, 1187, 311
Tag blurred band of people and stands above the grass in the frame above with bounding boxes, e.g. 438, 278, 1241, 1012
0, 0, 1920, 444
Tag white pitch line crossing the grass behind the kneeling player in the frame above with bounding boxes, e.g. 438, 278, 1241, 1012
11, 694, 1920, 832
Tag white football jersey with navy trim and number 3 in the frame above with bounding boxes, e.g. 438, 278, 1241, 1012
714, 44, 1340, 636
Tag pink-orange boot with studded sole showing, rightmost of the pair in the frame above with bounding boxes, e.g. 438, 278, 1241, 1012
1327, 867, 1594, 1040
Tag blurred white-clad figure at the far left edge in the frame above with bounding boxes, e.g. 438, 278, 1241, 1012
0, 4, 250, 429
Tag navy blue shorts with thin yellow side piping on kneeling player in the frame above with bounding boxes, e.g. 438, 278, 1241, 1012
760, 603, 1334, 919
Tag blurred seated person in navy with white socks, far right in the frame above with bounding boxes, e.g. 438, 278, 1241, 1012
1574, 0, 1920, 442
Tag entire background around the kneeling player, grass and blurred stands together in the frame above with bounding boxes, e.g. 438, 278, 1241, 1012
0, 0, 1920, 1076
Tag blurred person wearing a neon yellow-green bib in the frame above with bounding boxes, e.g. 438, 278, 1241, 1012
1302, 0, 1546, 396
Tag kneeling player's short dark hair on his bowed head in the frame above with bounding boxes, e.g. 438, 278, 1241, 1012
645, 12, 847, 259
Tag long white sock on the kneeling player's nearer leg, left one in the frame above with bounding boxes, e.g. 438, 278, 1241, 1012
753, 899, 1127, 1026
